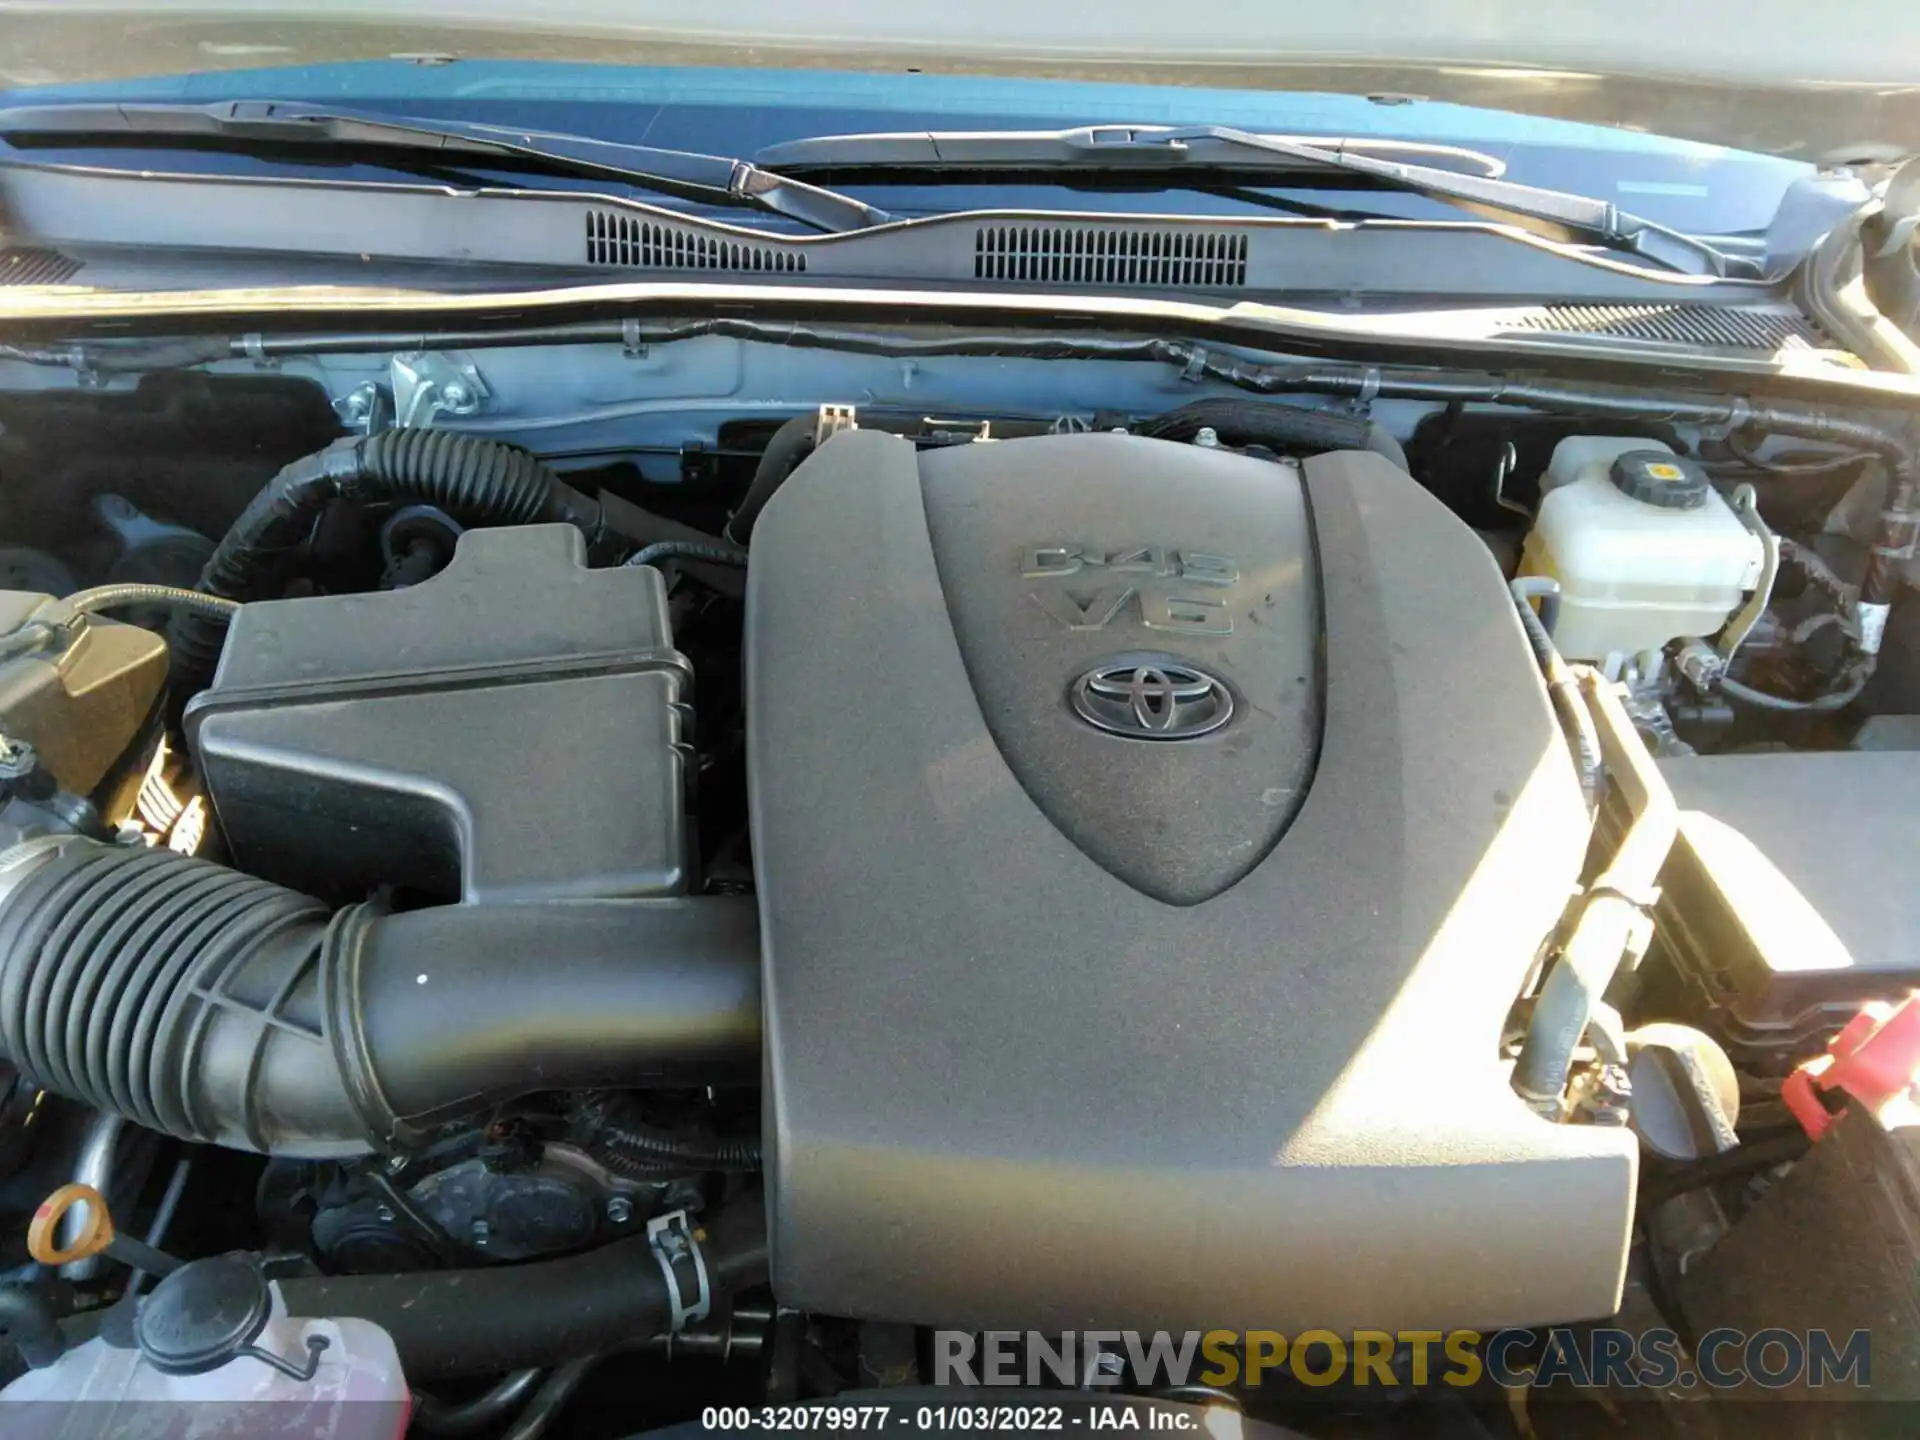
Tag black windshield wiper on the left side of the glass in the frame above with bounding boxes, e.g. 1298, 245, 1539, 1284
0, 100, 893, 232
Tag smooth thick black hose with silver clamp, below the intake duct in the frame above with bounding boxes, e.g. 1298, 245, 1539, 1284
278, 1202, 766, 1382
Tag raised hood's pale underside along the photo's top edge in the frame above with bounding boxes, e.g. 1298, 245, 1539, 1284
0, 0, 1920, 159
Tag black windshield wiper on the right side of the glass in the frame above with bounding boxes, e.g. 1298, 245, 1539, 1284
755, 125, 1751, 276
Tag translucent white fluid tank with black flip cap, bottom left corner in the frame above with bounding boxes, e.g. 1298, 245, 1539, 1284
0, 1254, 411, 1440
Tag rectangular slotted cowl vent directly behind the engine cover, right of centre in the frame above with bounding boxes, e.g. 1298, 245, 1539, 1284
973, 225, 1248, 290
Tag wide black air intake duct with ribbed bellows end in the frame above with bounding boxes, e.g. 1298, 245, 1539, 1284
0, 839, 760, 1156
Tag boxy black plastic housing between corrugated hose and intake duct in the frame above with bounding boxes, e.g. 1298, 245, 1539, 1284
186, 524, 691, 902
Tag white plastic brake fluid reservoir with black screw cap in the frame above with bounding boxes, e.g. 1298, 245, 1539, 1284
1521, 436, 1763, 672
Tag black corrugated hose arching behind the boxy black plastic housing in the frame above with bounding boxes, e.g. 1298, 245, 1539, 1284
167, 430, 566, 705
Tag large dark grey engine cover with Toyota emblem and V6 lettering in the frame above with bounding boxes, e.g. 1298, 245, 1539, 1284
747, 432, 1634, 1329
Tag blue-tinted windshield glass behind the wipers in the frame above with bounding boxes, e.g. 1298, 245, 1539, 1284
4, 60, 1811, 236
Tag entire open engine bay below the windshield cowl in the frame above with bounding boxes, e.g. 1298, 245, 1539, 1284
0, 336, 1920, 1436
